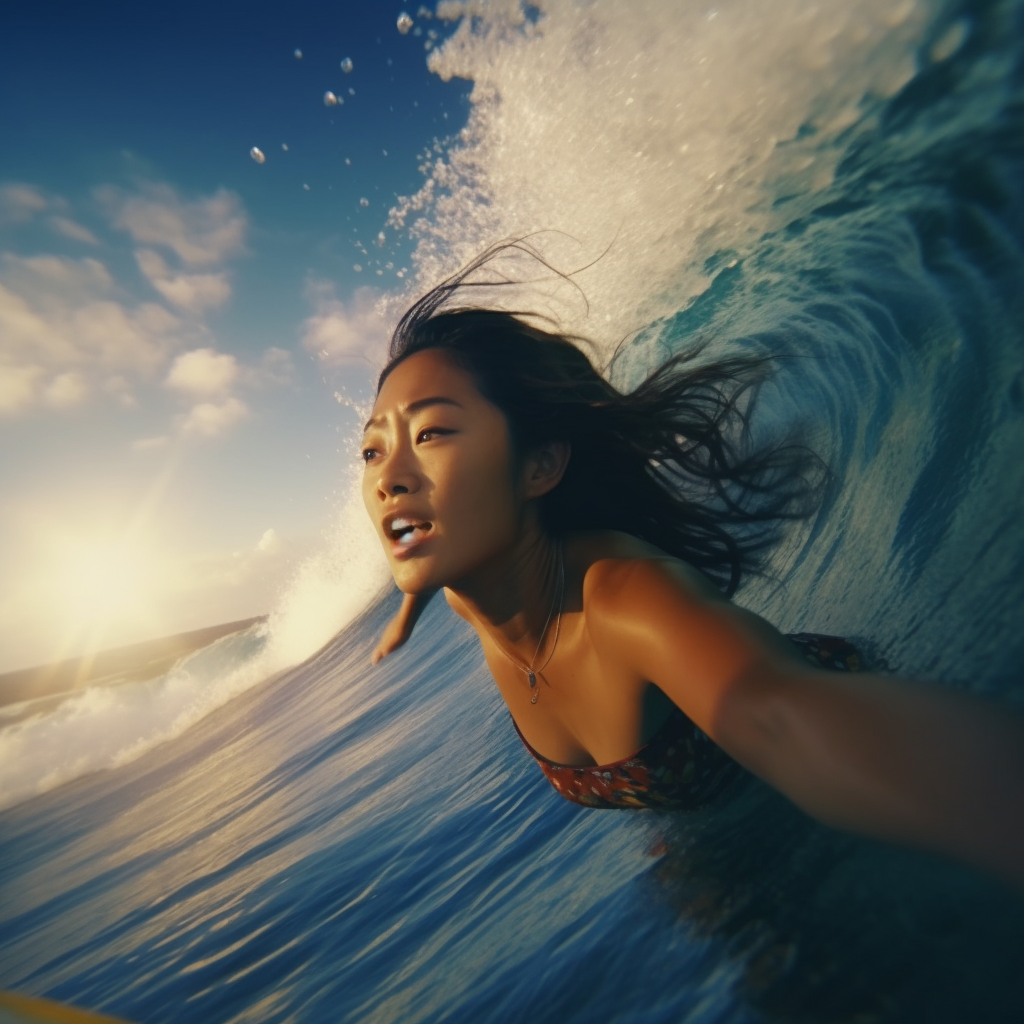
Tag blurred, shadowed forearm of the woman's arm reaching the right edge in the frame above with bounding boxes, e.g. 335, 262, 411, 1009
738, 673, 1024, 886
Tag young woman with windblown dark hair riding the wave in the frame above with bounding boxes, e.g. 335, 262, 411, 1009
362, 249, 1024, 886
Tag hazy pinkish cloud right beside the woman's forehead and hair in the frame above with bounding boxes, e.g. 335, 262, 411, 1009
302, 281, 388, 366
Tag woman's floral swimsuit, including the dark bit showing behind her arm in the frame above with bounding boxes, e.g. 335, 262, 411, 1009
512, 633, 860, 810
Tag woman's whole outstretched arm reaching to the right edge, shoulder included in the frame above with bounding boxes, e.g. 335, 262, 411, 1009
588, 561, 1024, 887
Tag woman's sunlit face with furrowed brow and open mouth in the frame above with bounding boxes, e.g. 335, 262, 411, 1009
362, 349, 524, 593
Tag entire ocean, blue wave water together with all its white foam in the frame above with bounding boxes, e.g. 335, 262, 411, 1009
0, 0, 1024, 1024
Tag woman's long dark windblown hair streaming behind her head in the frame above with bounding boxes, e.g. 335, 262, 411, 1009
377, 242, 822, 596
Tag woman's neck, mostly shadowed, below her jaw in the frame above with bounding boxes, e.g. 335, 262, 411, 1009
447, 523, 561, 666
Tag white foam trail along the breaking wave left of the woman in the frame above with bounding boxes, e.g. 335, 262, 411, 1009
0, 468, 387, 809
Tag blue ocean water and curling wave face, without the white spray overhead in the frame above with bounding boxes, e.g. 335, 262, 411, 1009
0, 2, 1024, 1024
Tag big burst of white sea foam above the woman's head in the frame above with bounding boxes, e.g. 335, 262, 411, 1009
390, 0, 934, 343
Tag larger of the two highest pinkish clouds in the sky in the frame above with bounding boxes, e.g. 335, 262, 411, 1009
96, 184, 248, 265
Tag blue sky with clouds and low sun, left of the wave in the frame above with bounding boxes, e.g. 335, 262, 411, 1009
0, 2, 469, 671
